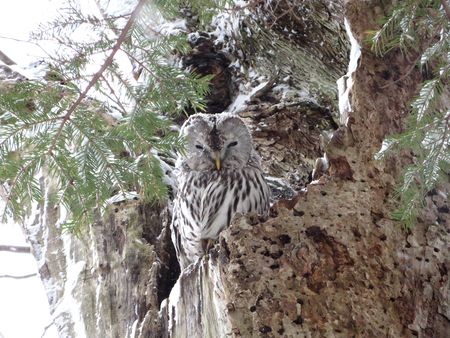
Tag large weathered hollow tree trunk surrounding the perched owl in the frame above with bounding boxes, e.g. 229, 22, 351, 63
10, 0, 450, 337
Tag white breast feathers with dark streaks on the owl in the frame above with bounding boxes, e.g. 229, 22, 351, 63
176, 167, 270, 258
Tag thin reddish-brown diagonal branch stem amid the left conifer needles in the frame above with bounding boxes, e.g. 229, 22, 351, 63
48, 0, 147, 154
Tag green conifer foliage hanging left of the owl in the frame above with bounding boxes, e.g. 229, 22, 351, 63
0, 0, 209, 229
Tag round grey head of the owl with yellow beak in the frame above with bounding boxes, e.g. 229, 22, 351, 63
180, 113, 254, 171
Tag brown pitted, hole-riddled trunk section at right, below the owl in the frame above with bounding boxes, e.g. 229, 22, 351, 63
160, 1, 450, 337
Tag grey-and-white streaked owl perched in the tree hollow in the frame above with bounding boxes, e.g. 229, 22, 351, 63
171, 113, 270, 269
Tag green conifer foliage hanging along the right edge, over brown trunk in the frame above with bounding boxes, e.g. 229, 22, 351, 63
373, 0, 450, 227
